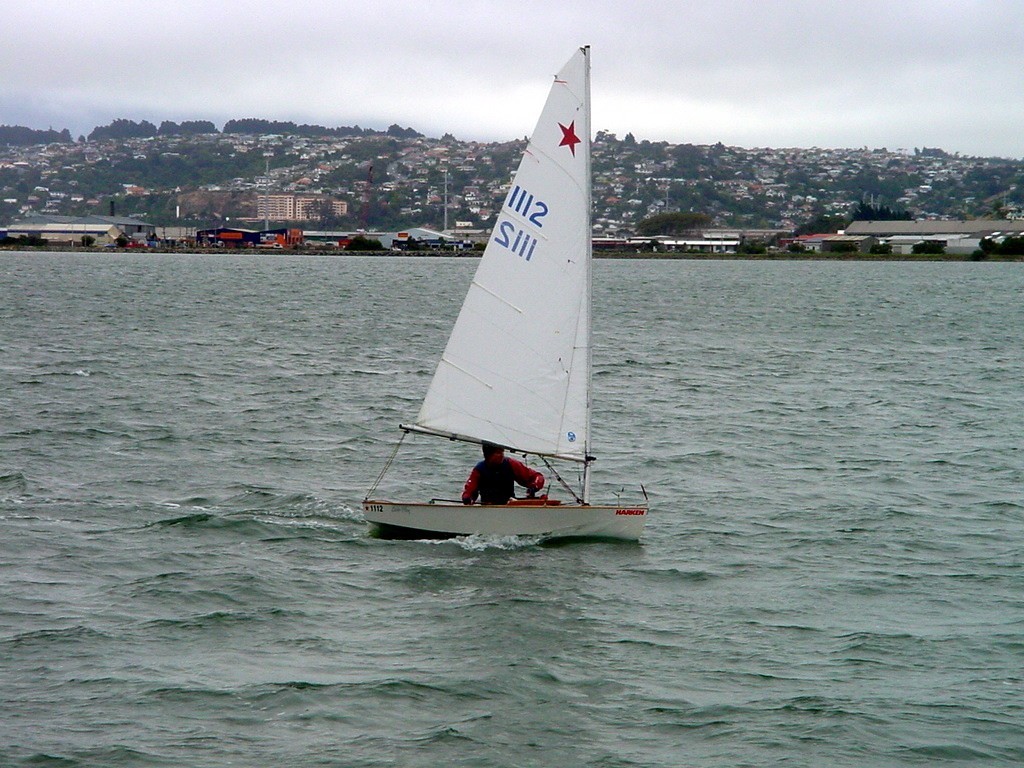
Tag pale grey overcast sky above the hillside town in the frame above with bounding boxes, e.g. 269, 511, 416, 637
8, 0, 1024, 158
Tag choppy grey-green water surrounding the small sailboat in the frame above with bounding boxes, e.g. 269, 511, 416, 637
0, 254, 1024, 767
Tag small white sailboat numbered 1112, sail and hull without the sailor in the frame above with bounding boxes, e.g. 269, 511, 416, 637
362, 46, 648, 540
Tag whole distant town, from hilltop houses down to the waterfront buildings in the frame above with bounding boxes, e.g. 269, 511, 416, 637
0, 120, 1024, 253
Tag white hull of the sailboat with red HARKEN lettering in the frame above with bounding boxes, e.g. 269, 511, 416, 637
362, 500, 647, 541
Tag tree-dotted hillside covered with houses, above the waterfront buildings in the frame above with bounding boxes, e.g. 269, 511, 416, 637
0, 121, 1024, 238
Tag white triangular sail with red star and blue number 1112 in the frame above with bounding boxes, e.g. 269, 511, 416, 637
411, 47, 591, 461
